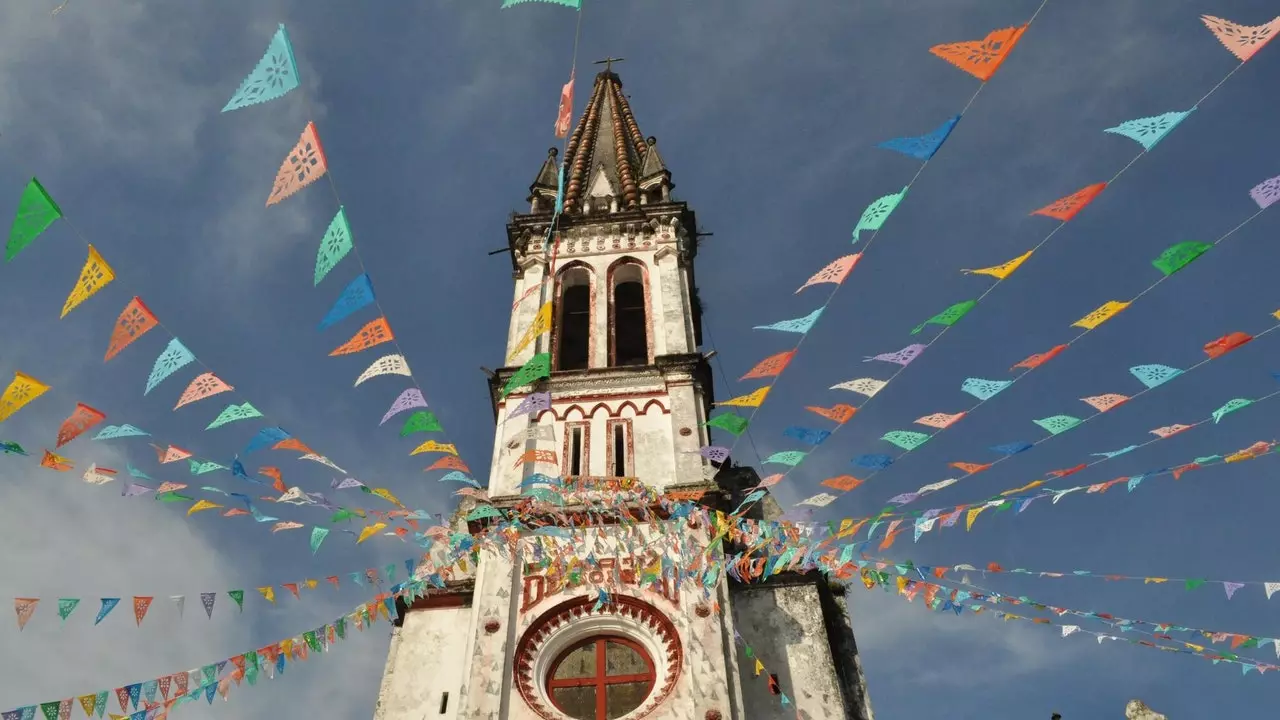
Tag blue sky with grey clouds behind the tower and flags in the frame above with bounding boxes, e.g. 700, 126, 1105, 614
0, 0, 1280, 720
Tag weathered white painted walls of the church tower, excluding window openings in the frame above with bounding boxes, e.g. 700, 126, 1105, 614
374, 72, 872, 720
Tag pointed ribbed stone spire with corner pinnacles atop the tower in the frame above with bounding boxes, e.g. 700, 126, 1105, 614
530, 69, 672, 215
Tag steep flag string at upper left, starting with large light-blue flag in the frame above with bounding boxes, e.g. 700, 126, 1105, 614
224, 24, 476, 484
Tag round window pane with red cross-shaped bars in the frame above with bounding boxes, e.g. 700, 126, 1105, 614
547, 635, 655, 720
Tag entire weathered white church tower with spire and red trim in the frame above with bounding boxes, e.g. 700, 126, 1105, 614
375, 60, 872, 720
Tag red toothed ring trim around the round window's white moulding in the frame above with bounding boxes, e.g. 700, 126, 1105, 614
515, 594, 685, 720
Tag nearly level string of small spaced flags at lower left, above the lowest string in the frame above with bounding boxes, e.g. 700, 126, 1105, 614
13, 557, 417, 630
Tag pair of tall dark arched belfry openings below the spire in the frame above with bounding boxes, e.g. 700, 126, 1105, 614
556, 259, 650, 370
